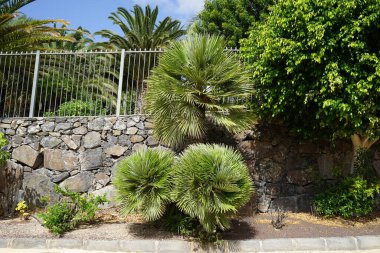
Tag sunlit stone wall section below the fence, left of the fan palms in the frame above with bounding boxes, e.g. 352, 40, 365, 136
0, 116, 158, 213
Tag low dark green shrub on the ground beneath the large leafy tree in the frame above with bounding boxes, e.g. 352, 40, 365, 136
313, 176, 379, 218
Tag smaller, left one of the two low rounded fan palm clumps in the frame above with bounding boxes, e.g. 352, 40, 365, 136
114, 149, 174, 221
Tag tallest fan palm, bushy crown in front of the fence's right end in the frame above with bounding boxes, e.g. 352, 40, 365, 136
144, 35, 253, 146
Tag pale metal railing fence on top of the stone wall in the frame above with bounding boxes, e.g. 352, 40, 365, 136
0, 49, 246, 118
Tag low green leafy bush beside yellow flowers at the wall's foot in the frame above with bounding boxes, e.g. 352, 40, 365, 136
38, 185, 108, 235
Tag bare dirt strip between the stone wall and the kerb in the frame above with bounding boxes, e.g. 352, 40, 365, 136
0, 209, 380, 240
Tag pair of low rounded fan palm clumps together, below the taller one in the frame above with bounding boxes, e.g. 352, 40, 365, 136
114, 144, 253, 242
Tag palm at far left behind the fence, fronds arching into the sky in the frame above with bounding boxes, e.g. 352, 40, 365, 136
0, 0, 75, 116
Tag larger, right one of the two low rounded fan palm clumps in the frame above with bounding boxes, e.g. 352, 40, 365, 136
173, 144, 253, 234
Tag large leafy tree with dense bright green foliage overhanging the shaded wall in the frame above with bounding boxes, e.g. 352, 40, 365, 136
242, 0, 380, 168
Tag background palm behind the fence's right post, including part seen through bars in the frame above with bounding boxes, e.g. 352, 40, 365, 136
95, 5, 186, 113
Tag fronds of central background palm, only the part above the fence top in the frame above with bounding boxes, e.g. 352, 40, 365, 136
96, 5, 185, 49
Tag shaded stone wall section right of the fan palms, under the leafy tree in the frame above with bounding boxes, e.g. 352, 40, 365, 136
235, 125, 380, 212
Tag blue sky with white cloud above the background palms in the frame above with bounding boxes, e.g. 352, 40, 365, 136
21, 0, 204, 39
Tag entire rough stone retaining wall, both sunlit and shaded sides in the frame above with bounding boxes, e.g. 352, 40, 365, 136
0, 116, 380, 215
